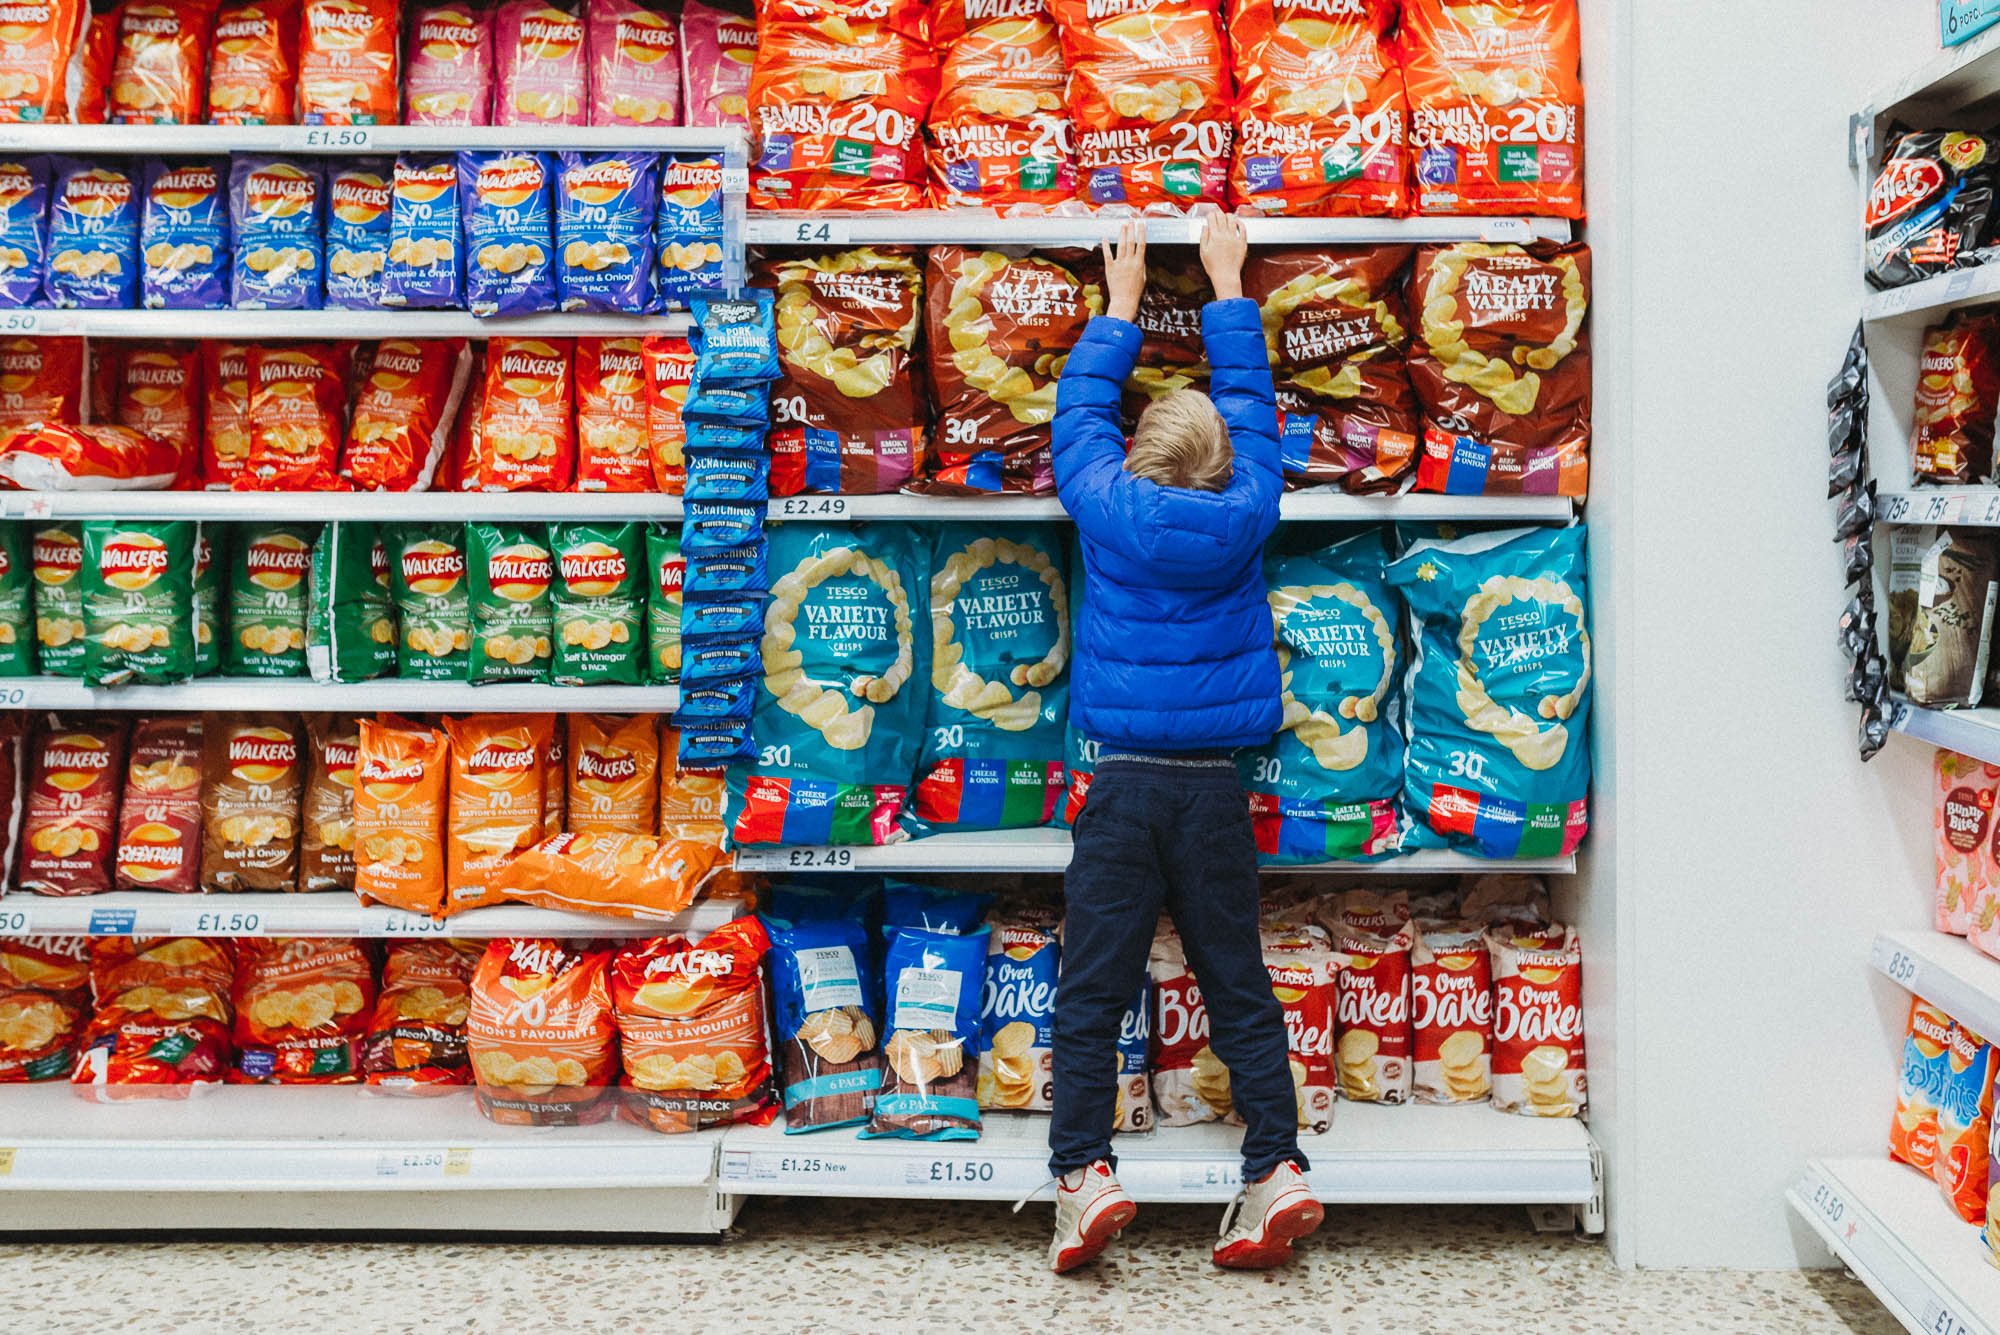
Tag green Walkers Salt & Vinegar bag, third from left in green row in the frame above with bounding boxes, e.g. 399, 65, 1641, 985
84, 520, 200, 685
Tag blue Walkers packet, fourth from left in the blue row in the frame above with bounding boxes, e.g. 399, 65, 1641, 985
230, 154, 326, 310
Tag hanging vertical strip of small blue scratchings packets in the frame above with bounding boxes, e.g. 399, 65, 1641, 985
676, 290, 780, 771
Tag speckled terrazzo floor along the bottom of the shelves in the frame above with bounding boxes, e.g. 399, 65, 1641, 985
0, 1199, 1900, 1335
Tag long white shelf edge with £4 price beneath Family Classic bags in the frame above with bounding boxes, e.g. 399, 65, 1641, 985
744, 208, 1570, 246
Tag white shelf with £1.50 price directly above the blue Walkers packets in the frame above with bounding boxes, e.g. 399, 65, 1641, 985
0, 126, 746, 154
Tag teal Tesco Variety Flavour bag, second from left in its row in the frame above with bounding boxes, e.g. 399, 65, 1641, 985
904, 524, 1070, 833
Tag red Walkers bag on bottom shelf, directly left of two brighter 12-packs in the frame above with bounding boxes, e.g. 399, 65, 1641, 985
362, 939, 486, 1095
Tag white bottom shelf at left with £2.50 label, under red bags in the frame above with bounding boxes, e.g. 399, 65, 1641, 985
0, 1081, 718, 1191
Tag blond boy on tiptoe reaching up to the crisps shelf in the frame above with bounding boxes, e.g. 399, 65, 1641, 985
1048, 216, 1322, 1271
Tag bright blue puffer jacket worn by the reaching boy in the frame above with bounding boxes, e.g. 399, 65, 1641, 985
1054, 298, 1284, 751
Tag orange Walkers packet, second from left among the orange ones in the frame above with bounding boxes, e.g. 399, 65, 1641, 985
444, 713, 556, 913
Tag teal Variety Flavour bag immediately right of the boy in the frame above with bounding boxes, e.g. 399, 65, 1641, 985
1236, 530, 1406, 863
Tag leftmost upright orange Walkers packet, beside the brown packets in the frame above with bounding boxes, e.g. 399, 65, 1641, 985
354, 717, 450, 915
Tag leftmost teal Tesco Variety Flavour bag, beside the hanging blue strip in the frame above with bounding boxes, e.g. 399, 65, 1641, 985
728, 524, 930, 843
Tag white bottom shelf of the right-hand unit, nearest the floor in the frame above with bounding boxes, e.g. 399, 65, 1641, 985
1786, 1157, 2000, 1335
